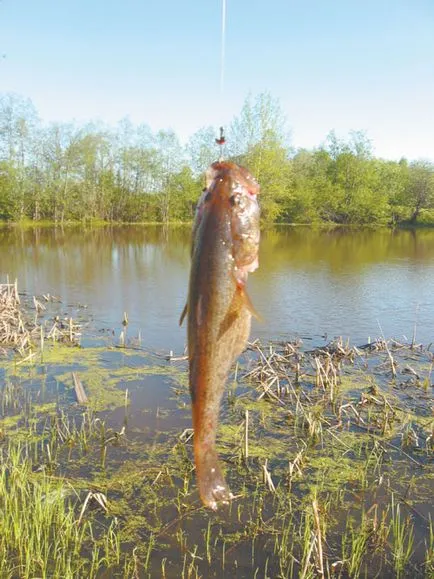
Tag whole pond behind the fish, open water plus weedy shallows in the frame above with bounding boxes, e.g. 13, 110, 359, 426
0, 226, 434, 579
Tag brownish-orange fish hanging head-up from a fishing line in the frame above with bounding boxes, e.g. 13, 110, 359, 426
180, 161, 260, 510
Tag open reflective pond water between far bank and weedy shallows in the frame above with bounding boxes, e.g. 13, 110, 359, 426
0, 226, 434, 352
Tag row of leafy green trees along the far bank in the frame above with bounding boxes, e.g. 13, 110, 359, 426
0, 93, 434, 226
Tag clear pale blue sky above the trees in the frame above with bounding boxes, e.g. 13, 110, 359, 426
0, 0, 434, 160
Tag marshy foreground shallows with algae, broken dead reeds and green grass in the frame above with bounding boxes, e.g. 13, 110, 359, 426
0, 285, 434, 578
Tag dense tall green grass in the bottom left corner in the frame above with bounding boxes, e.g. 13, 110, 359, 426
0, 443, 134, 578
